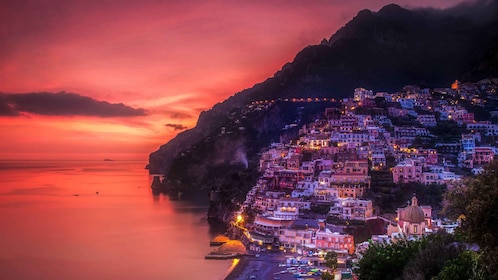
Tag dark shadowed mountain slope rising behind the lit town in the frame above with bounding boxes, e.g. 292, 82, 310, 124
149, 1, 498, 221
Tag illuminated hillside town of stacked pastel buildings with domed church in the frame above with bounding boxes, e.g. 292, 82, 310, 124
222, 79, 498, 279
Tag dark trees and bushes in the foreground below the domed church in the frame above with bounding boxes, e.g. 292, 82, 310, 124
356, 161, 498, 280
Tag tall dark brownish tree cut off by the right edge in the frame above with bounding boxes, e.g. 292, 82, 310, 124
445, 161, 498, 279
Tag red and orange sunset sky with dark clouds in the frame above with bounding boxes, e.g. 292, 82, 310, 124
0, 0, 462, 161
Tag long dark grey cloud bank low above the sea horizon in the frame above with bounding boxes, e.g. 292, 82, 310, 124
0, 92, 147, 118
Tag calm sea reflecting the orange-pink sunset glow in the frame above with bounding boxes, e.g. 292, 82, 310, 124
0, 161, 232, 280
